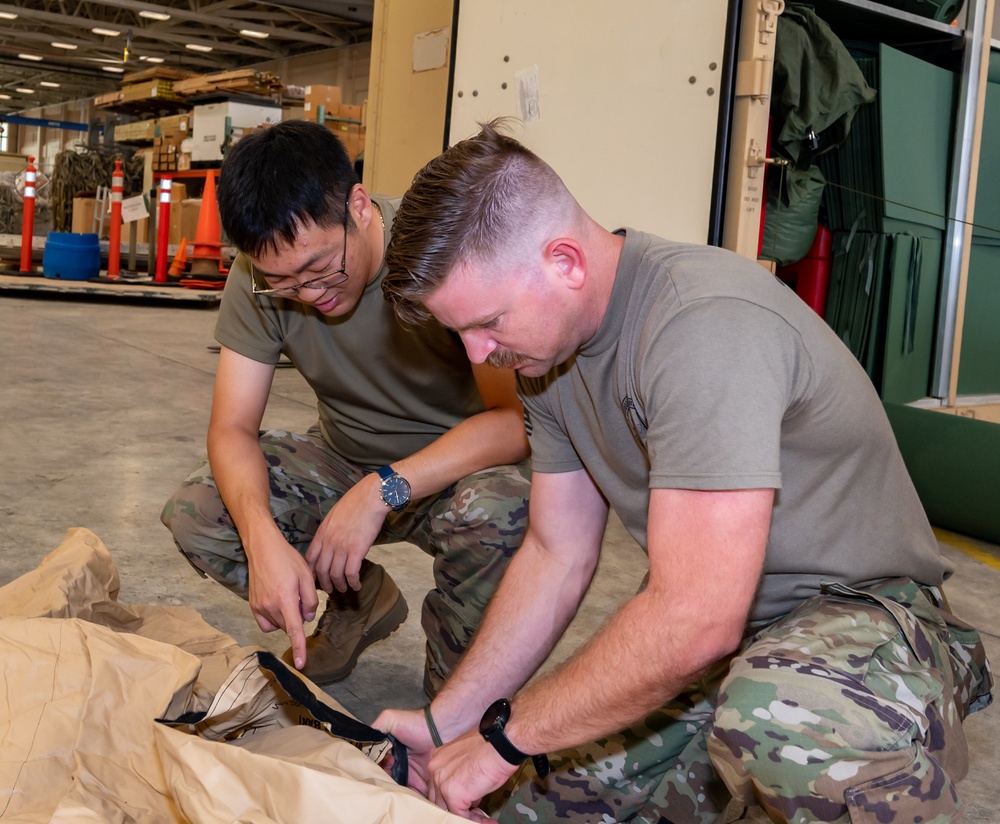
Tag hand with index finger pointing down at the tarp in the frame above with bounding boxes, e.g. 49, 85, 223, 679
247, 535, 319, 669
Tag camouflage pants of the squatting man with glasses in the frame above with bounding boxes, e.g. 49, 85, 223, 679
160, 427, 530, 679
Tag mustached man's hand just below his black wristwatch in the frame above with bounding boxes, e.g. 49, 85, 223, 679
426, 730, 519, 821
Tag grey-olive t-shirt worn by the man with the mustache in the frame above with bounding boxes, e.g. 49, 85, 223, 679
519, 229, 950, 620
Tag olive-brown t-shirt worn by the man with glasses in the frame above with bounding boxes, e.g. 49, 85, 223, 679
215, 192, 483, 468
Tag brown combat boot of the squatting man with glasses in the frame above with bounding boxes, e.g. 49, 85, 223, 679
281, 560, 407, 686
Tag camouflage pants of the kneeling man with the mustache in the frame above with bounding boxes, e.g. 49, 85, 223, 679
484, 579, 992, 824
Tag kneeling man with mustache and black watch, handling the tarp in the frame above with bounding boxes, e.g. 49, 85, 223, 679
375, 124, 992, 824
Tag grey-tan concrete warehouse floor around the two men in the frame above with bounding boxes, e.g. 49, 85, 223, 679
0, 292, 1000, 822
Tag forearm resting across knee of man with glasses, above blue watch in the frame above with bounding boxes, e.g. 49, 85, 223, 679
392, 408, 529, 499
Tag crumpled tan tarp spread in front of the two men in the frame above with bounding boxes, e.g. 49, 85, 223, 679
0, 529, 461, 824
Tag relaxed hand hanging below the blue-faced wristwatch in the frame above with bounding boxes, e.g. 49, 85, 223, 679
305, 475, 389, 592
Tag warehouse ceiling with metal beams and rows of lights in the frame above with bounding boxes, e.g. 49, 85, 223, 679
0, 0, 374, 114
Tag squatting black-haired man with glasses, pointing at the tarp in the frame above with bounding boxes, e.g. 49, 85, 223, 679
161, 121, 528, 695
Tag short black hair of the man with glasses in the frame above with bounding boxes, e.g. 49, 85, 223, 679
217, 120, 358, 257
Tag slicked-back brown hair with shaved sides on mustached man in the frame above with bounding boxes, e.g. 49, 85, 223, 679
382, 120, 564, 323
